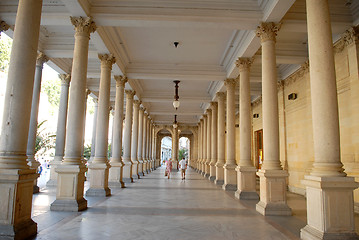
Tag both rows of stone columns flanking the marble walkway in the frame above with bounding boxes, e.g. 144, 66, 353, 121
0, 0, 357, 239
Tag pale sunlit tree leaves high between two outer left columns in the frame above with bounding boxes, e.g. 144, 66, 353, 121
41, 78, 61, 115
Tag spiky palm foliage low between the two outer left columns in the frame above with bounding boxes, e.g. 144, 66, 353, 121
34, 120, 56, 158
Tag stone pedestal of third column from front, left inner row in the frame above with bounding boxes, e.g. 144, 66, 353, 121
86, 161, 111, 197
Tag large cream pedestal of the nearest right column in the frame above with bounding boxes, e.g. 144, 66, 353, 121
300, 176, 359, 240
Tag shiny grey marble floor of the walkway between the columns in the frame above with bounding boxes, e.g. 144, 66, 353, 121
29, 167, 356, 240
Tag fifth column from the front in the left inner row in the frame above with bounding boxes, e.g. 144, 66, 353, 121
122, 90, 135, 183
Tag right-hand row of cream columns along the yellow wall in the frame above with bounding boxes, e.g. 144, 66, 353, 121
192, 0, 358, 239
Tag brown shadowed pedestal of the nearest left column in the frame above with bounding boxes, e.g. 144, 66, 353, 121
0, 169, 39, 239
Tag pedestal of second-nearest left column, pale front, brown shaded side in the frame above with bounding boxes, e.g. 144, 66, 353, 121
50, 164, 87, 212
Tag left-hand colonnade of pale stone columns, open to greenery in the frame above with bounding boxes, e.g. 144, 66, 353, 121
0, 0, 157, 239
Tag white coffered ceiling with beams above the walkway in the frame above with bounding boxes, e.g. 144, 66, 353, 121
0, 0, 359, 125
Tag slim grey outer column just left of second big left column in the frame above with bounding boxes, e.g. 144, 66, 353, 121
46, 74, 71, 187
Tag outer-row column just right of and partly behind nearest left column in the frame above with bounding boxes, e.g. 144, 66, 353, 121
26, 52, 49, 193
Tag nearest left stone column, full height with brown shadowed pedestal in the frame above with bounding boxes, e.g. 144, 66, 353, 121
0, 0, 42, 239
